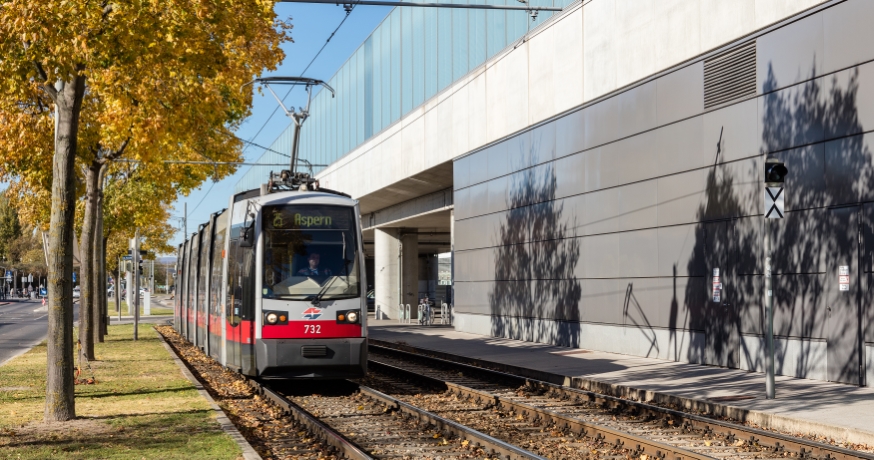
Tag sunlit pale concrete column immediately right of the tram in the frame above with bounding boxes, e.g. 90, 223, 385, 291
373, 228, 400, 319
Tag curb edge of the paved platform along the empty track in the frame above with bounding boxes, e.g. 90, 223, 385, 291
368, 338, 874, 446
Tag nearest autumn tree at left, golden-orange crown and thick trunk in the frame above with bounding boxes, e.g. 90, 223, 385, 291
0, 0, 290, 421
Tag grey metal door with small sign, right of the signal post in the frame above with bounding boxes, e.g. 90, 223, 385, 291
824, 206, 864, 385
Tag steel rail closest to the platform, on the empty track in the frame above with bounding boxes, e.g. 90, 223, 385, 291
370, 343, 874, 460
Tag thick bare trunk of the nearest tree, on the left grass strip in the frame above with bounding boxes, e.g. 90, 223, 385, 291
44, 73, 85, 422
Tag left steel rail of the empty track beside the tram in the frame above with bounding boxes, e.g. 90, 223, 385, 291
370, 359, 714, 460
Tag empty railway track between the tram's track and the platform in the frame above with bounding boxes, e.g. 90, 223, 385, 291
370, 344, 874, 460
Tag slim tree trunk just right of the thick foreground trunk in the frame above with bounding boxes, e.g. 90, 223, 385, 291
79, 160, 100, 361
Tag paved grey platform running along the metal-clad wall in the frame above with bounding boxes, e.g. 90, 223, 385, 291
368, 319, 874, 446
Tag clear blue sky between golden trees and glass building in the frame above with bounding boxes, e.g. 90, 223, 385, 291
170, 3, 391, 250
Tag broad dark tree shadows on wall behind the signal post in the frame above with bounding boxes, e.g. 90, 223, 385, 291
684, 61, 874, 381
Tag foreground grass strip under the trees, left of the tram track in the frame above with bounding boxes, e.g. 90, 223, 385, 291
0, 325, 241, 460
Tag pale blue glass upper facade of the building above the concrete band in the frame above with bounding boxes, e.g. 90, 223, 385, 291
235, 0, 573, 192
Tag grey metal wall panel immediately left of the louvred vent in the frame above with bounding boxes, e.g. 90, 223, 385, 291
656, 62, 704, 125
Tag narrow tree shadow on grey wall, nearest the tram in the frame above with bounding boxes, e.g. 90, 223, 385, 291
489, 159, 582, 347
